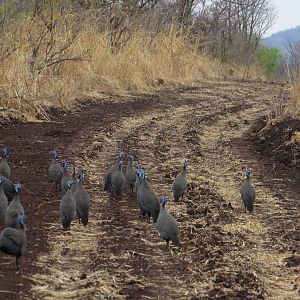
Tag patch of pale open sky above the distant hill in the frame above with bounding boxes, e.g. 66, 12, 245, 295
265, 0, 300, 36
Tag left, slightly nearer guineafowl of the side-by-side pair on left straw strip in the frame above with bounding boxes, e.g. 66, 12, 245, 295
59, 180, 76, 230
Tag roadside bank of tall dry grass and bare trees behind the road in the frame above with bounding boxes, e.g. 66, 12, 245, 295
0, 0, 273, 118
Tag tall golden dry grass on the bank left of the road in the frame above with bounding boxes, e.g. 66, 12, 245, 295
0, 14, 260, 119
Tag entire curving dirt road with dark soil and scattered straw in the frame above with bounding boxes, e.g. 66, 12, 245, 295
0, 82, 300, 299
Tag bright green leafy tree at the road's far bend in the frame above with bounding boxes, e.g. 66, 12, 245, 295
257, 45, 282, 79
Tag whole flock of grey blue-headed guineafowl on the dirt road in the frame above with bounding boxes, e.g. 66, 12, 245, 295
0, 148, 255, 271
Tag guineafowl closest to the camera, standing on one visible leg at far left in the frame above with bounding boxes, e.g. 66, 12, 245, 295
0, 215, 26, 271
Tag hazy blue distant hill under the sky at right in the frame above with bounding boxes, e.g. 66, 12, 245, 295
262, 26, 300, 52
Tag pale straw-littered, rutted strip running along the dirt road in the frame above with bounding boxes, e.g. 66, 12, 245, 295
0, 82, 297, 299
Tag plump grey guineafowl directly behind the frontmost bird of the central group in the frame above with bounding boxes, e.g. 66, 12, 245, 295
138, 172, 160, 223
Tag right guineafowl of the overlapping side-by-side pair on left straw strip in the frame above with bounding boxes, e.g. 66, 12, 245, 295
73, 173, 90, 226
